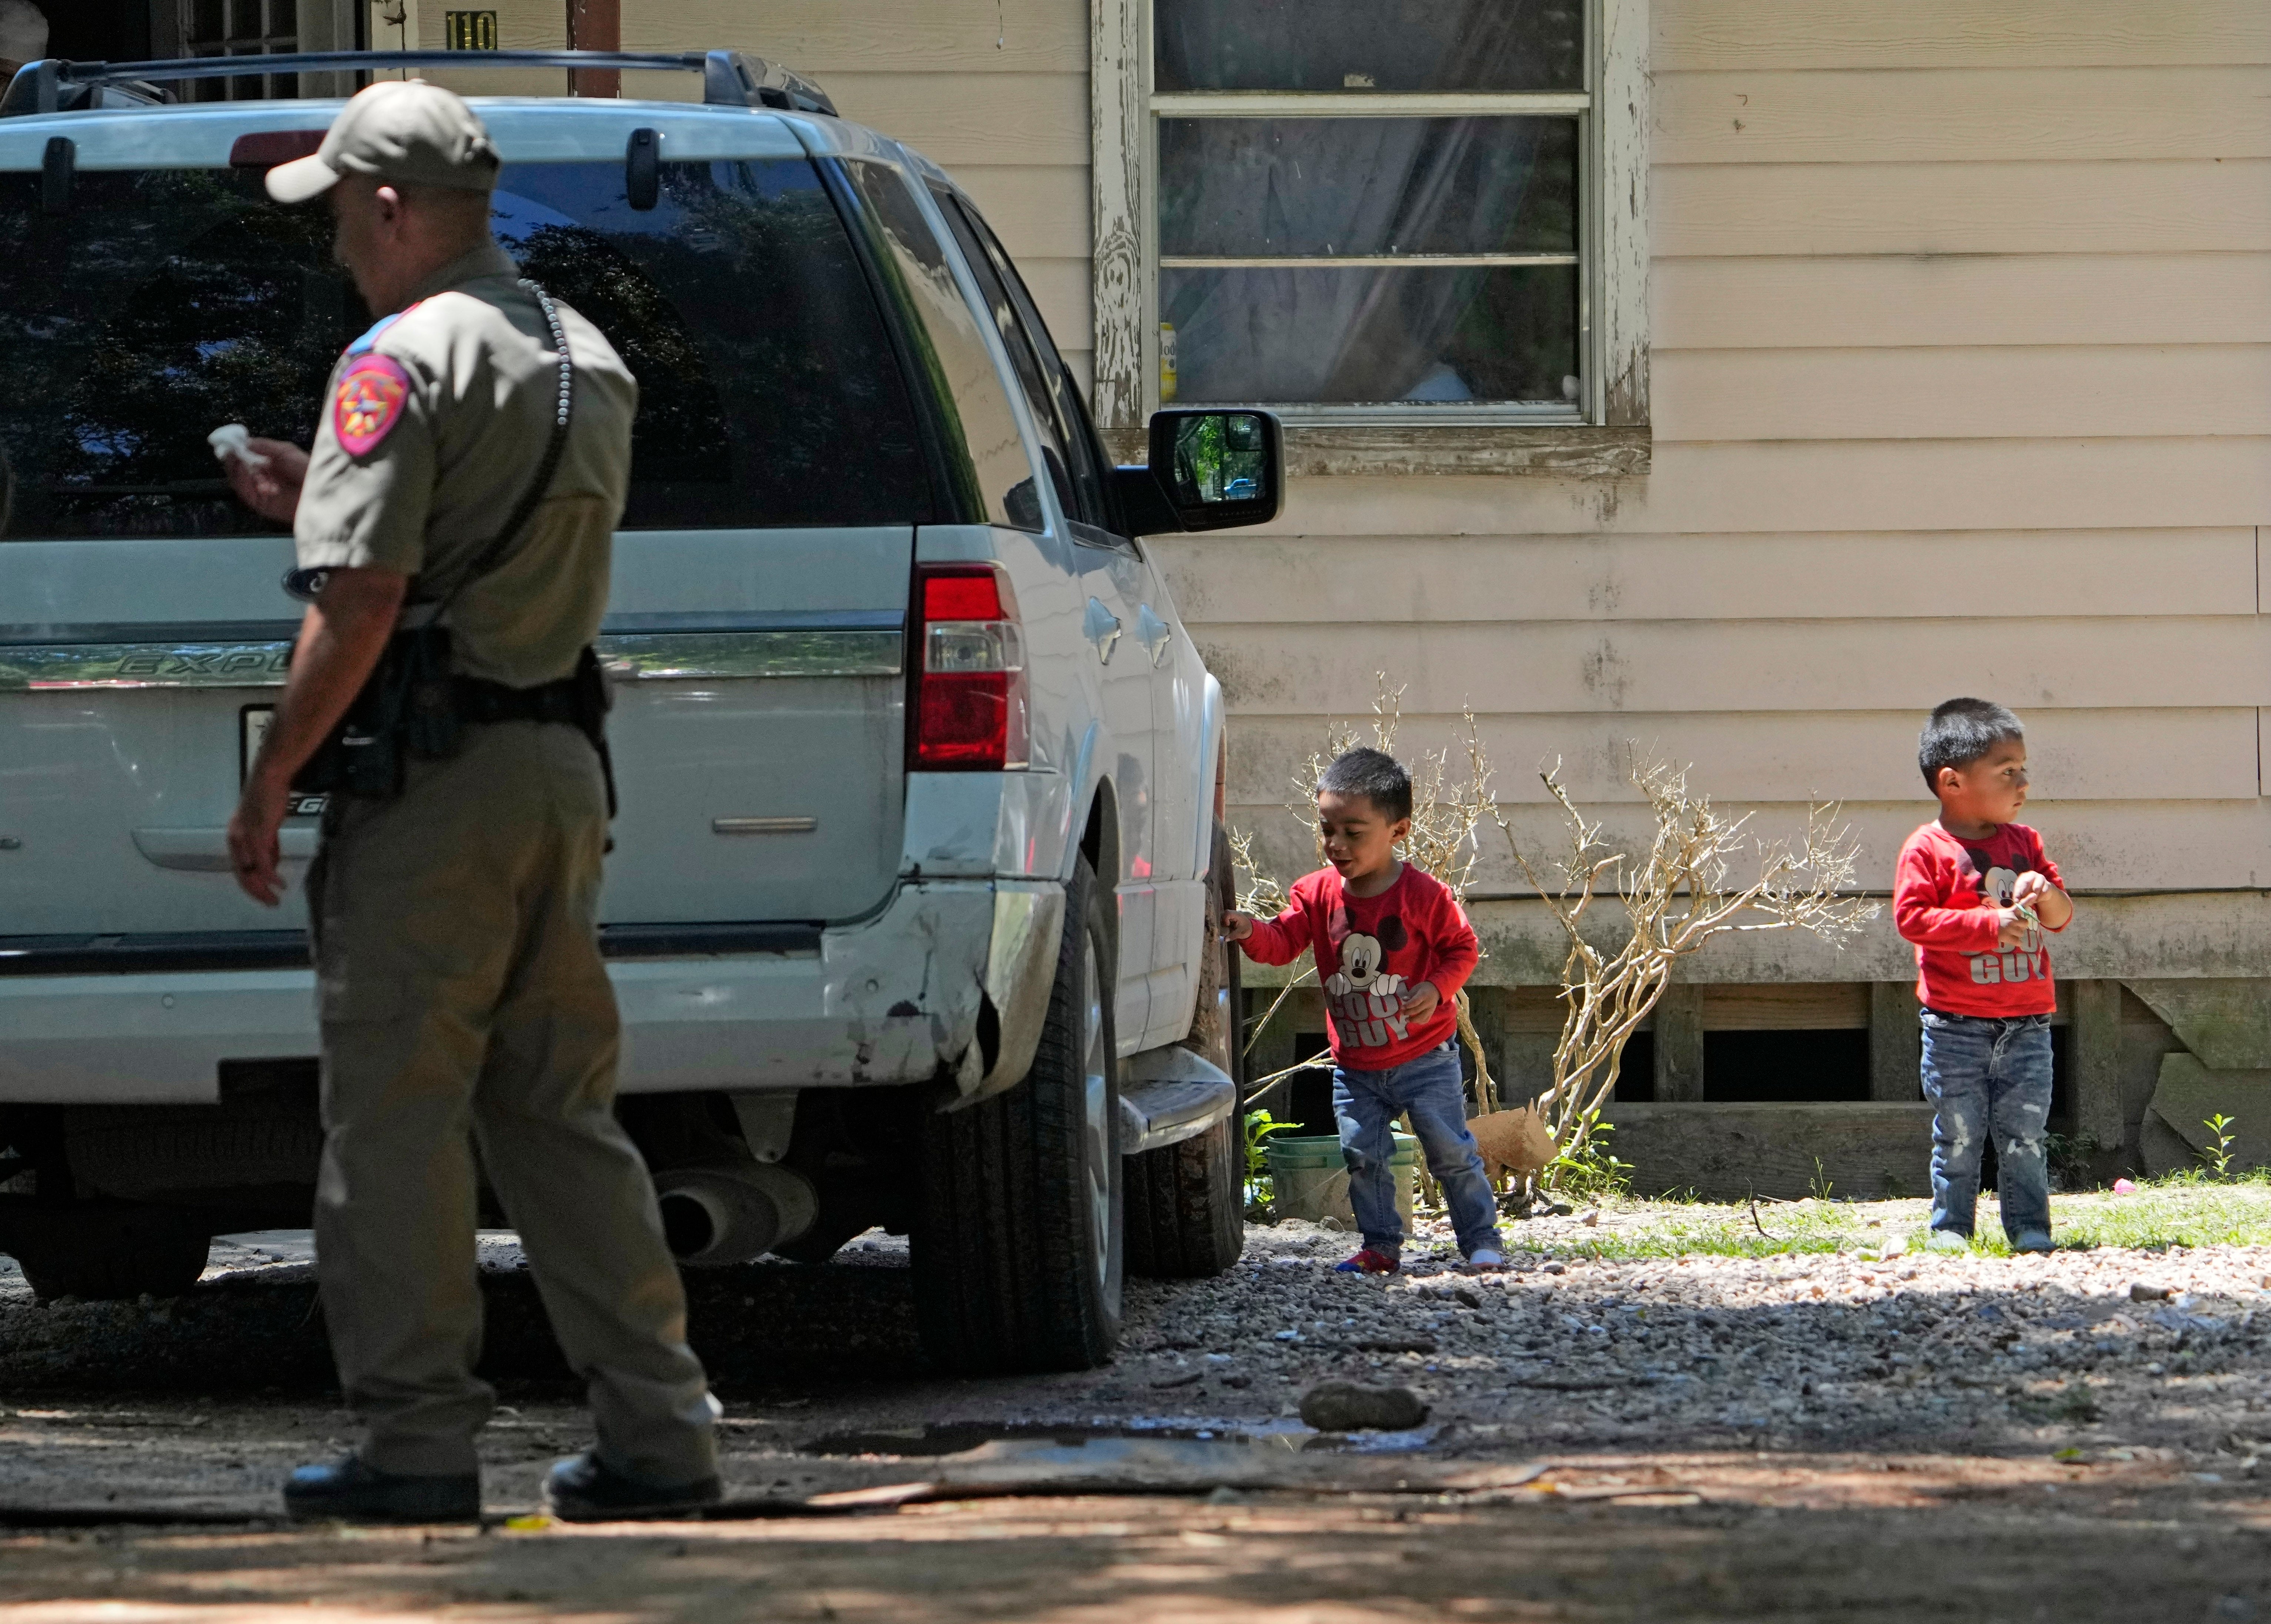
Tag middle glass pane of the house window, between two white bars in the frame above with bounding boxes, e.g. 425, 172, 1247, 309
1158, 118, 1578, 259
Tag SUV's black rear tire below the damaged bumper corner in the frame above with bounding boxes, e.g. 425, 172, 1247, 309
911, 859, 1124, 1374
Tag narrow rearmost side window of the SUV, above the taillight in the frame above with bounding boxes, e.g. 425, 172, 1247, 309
845, 164, 1042, 529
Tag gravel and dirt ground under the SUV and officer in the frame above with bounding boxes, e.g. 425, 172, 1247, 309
0, 1204, 2271, 1624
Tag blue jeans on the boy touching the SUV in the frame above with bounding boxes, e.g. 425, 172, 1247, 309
1333, 1043, 1506, 1258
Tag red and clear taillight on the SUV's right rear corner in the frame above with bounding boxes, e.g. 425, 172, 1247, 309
913, 563, 1026, 772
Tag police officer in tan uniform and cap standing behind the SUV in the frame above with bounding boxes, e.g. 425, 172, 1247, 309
229, 82, 718, 1520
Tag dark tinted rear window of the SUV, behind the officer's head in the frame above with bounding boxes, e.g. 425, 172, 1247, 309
0, 159, 934, 538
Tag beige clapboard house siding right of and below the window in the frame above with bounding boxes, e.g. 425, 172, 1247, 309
1160, 0, 2271, 977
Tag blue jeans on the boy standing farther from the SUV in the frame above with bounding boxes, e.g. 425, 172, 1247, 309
1924, 1009, 2051, 1242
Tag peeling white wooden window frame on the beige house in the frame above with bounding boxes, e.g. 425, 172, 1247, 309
1090, 0, 1649, 477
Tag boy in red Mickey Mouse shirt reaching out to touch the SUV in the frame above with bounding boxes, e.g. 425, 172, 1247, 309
1222, 749, 1506, 1274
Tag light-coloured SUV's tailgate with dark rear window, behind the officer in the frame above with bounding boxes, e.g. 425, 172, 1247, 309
0, 117, 931, 938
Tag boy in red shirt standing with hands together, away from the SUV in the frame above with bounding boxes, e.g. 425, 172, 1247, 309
1892, 699, 2073, 1252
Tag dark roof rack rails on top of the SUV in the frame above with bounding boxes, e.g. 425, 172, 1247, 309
0, 50, 838, 118
